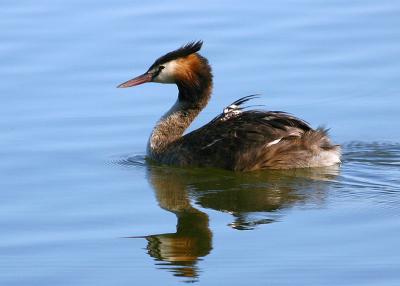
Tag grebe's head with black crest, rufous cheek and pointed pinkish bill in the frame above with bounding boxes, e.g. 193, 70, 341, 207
118, 41, 211, 87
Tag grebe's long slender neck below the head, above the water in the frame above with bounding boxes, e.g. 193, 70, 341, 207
147, 78, 212, 159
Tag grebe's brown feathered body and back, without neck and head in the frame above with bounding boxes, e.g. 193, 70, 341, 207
164, 96, 340, 171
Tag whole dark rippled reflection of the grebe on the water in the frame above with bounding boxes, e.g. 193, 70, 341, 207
126, 162, 338, 281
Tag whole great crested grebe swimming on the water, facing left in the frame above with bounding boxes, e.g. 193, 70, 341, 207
118, 41, 340, 171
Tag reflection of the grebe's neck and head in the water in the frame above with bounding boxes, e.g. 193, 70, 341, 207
146, 167, 212, 280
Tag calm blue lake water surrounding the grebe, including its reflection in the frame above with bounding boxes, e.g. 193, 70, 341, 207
0, 0, 400, 286
